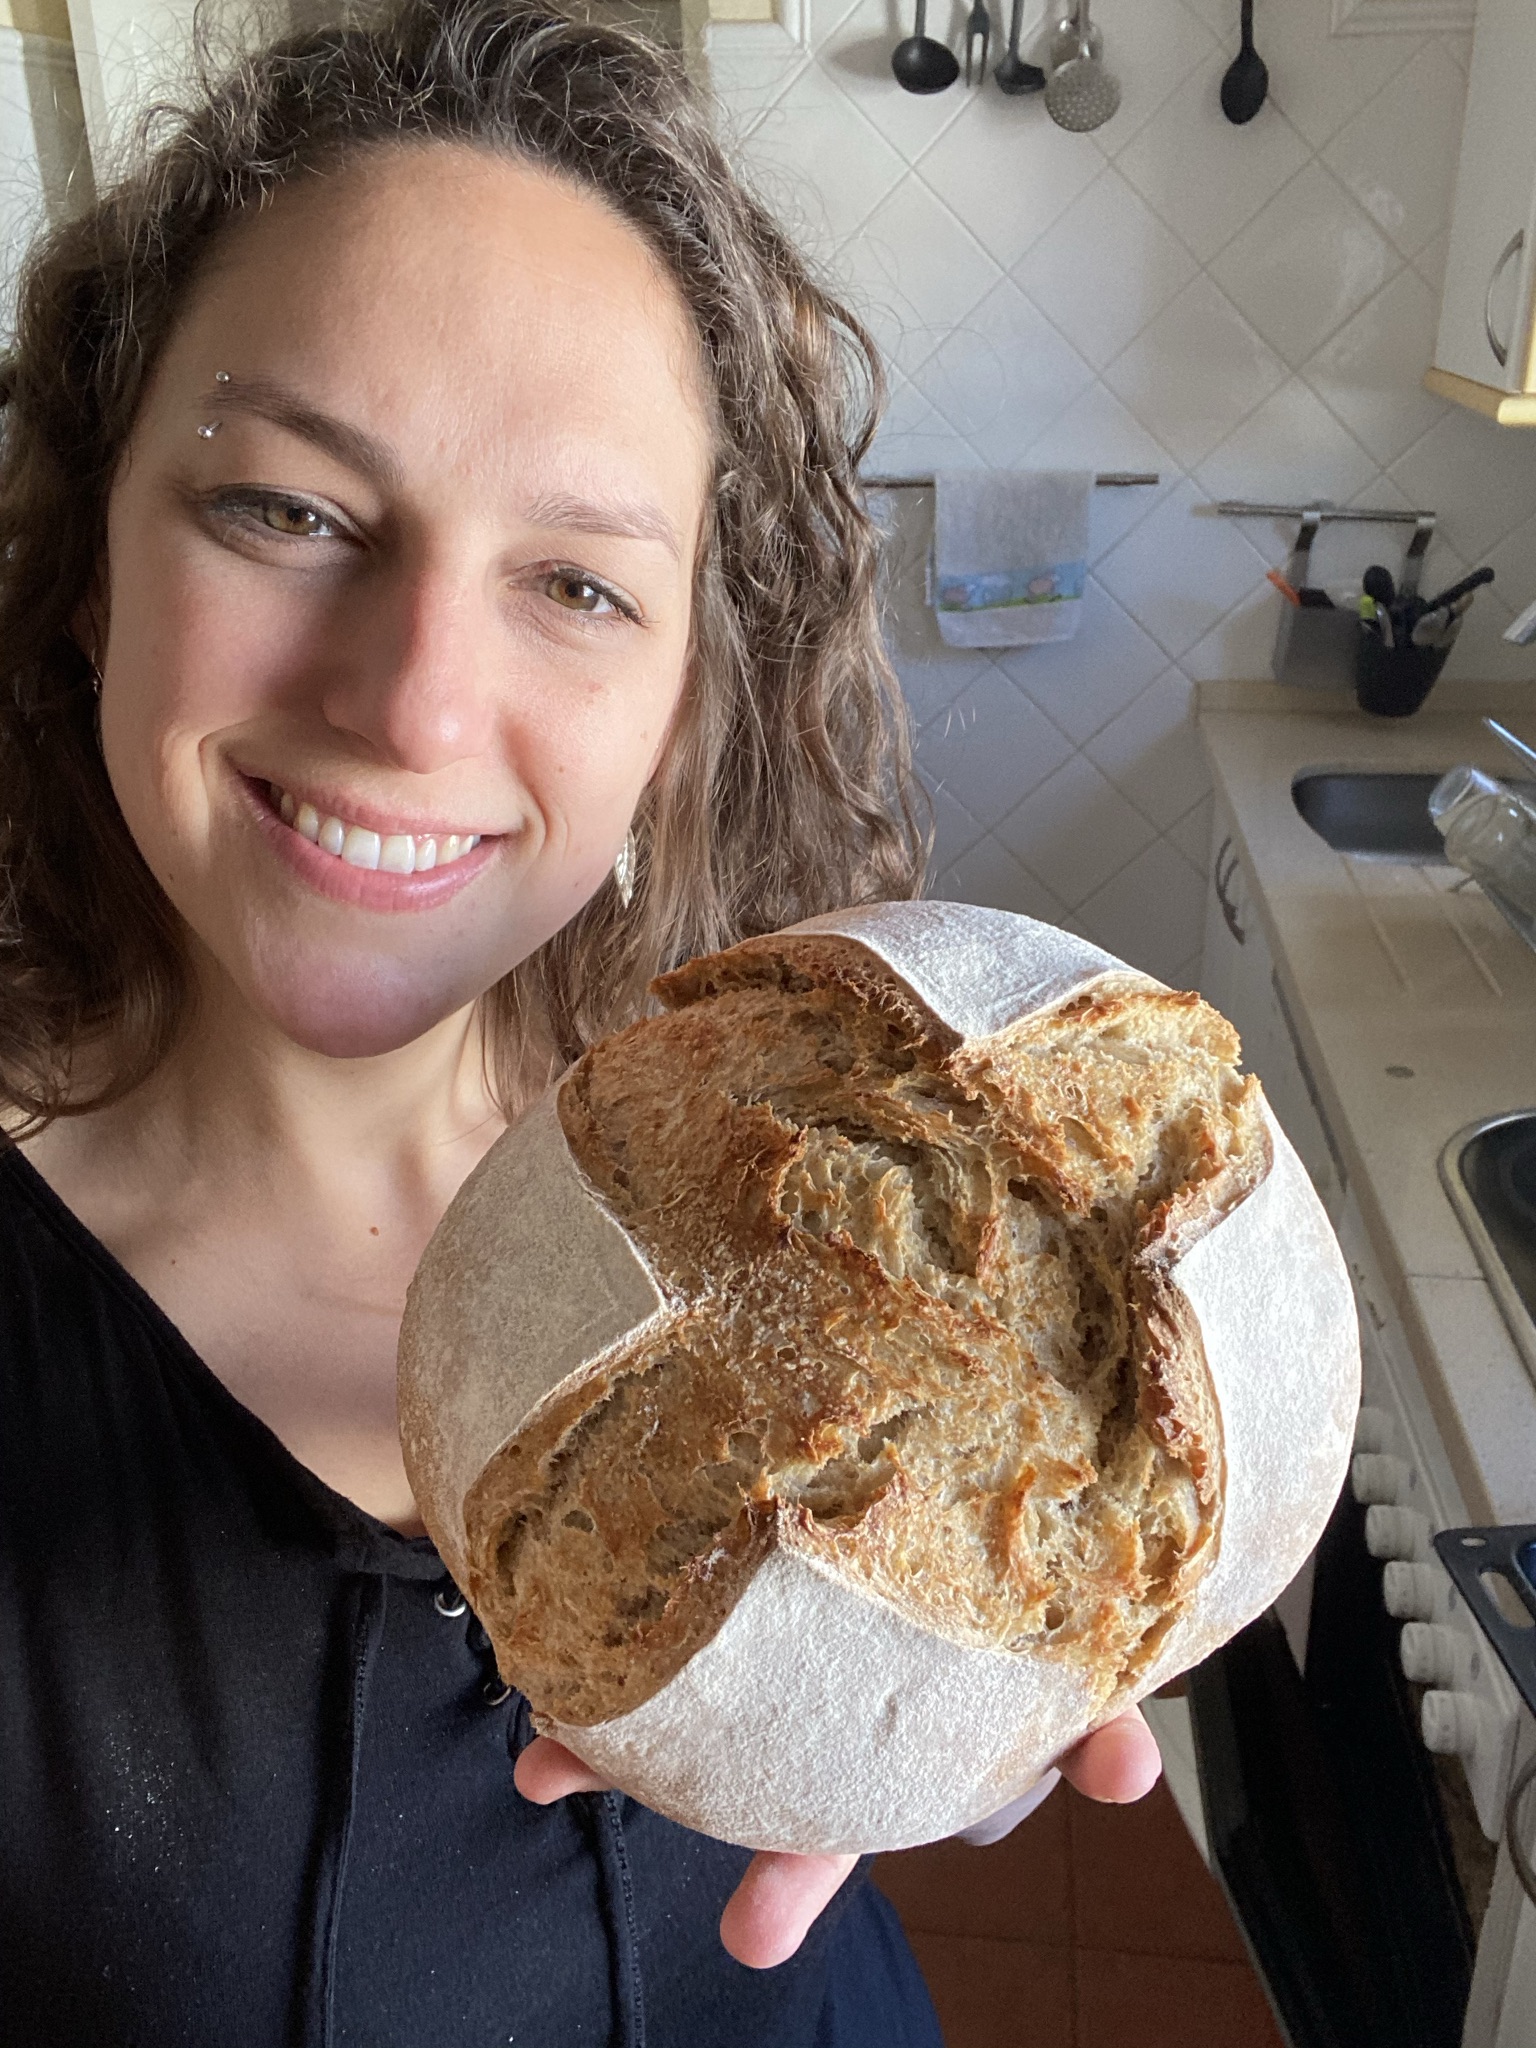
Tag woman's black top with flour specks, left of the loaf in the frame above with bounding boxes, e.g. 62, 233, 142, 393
0, 1149, 940, 2048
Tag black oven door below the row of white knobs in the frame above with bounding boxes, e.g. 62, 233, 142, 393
1190, 1491, 1475, 2048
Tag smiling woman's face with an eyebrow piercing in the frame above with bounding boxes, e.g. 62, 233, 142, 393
96, 145, 711, 1057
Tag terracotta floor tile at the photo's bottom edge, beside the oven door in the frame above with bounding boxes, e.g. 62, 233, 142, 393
1075, 1948, 1284, 2048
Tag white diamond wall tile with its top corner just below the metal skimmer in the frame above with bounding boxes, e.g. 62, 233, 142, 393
1014, 168, 1196, 369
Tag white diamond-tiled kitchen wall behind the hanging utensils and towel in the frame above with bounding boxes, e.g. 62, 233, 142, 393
711, 0, 1536, 983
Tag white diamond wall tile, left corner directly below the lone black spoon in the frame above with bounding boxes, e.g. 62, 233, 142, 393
1210, 160, 1401, 369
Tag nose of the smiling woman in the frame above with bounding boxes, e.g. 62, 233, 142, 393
322, 567, 504, 774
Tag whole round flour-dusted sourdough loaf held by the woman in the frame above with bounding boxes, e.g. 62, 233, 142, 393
399, 903, 1358, 1849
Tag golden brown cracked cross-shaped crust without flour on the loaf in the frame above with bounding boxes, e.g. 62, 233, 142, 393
465, 934, 1268, 1726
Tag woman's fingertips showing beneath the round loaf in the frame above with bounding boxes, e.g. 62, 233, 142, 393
514, 1710, 1163, 1970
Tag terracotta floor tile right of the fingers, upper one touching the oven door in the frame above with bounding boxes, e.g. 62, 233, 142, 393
1061, 1784, 1247, 1966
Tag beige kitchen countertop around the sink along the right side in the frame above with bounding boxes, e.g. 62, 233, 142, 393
1200, 684, 1536, 1522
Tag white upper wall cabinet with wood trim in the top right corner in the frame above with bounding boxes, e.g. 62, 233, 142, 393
1425, 0, 1536, 426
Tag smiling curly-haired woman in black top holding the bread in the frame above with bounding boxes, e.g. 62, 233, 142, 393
0, 0, 1155, 2048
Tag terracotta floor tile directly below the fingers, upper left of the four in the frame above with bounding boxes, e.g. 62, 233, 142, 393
874, 1792, 1073, 1948
